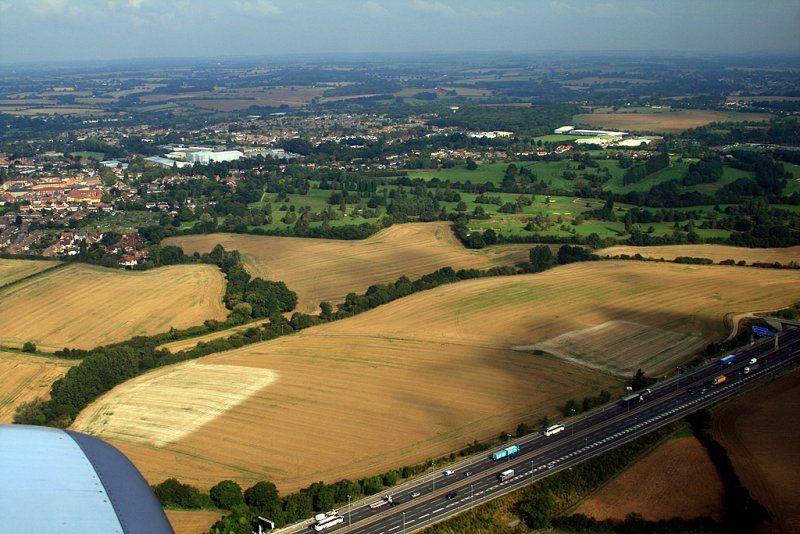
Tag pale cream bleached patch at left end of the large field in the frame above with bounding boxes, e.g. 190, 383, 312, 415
73, 362, 277, 447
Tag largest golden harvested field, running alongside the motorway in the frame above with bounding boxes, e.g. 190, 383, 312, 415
74, 261, 800, 491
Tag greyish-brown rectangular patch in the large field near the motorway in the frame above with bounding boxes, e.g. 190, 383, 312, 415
513, 321, 704, 376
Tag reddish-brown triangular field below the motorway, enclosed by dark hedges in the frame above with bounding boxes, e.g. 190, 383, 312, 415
576, 437, 725, 521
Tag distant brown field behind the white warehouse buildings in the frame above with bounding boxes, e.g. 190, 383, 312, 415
572, 109, 772, 133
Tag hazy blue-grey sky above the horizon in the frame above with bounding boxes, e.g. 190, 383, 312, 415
0, 0, 800, 63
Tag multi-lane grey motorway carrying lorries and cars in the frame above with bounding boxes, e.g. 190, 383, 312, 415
290, 329, 800, 534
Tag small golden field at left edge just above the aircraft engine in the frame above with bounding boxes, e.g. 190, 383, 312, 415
0, 350, 78, 423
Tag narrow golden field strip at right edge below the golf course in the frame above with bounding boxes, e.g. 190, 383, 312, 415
597, 245, 800, 265
